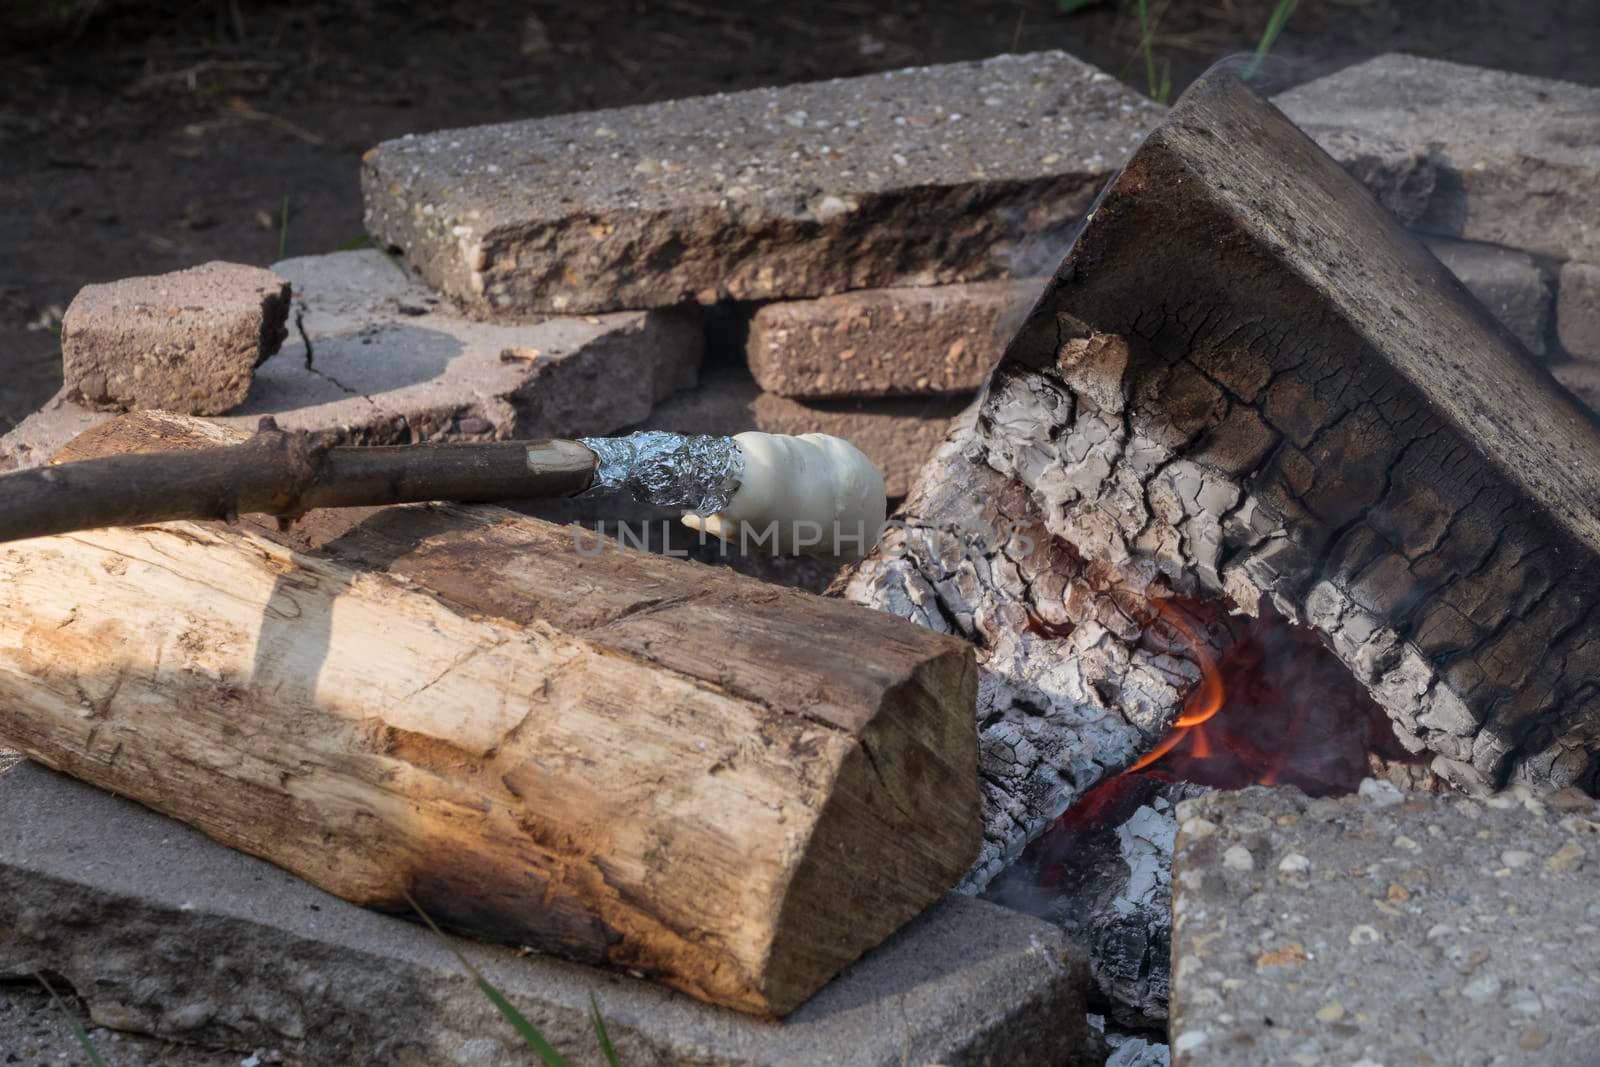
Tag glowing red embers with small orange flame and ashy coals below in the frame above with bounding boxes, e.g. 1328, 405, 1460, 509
986, 598, 1426, 1030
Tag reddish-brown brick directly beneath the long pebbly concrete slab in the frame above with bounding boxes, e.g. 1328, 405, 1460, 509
747, 280, 1043, 398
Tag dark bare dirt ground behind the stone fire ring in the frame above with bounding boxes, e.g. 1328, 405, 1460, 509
0, 0, 1600, 432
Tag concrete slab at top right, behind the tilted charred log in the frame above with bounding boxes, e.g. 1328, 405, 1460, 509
1274, 54, 1600, 262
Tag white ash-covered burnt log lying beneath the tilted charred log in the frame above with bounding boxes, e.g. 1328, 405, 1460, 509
843, 412, 1200, 893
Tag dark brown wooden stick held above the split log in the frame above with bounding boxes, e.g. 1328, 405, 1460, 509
0, 419, 595, 542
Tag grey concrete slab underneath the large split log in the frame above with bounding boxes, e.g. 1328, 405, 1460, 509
0, 763, 1099, 1067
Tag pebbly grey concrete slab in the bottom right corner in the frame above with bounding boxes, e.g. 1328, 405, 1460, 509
1170, 781, 1600, 1067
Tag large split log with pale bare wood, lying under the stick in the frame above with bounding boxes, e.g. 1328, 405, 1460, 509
0, 413, 979, 1014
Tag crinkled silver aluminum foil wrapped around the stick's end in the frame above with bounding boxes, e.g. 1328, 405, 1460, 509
578, 430, 744, 515
